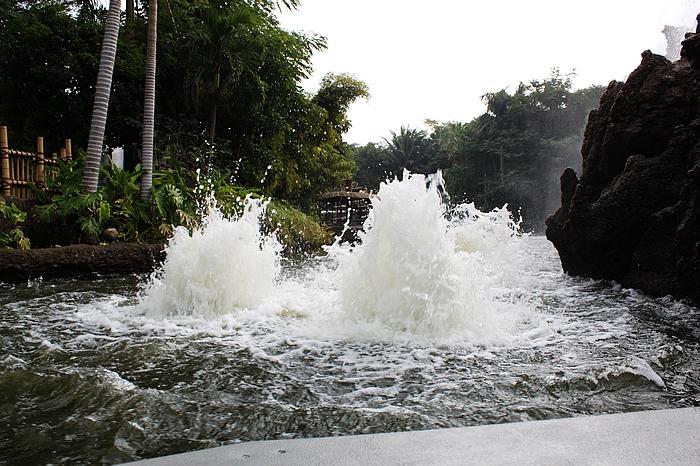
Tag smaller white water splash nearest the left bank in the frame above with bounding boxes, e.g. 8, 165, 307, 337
143, 197, 282, 317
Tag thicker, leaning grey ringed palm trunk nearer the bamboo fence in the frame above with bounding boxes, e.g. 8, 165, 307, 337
83, 0, 121, 193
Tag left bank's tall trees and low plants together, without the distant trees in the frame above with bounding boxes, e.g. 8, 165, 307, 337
0, 0, 369, 251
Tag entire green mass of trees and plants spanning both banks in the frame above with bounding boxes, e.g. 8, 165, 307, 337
0, 0, 602, 244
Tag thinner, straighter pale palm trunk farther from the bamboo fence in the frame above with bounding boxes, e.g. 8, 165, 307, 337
141, 0, 158, 201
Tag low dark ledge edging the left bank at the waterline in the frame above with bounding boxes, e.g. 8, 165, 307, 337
0, 243, 165, 283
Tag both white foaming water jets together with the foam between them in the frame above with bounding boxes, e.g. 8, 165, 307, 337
143, 173, 531, 342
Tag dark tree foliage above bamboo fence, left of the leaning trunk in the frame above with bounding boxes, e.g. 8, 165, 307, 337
0, 2, 104, 149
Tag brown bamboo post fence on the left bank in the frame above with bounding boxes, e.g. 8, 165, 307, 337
0, 126, 73, 198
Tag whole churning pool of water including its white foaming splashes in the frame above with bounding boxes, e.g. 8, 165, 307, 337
0, 176, 700, 464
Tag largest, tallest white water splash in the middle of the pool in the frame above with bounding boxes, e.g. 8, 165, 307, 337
329, 173, 516, 337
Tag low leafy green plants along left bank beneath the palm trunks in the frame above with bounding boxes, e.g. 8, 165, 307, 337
27, 148, 333, 254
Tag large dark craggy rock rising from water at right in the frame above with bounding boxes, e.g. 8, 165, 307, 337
546, 39, 700, 304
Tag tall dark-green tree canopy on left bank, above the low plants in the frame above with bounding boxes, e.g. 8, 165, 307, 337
0, 0, 369, 204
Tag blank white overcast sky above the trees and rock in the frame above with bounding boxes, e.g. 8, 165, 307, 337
278, 0, 700, 144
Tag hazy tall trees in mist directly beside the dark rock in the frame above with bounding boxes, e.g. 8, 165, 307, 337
446, 68, 602, 229
